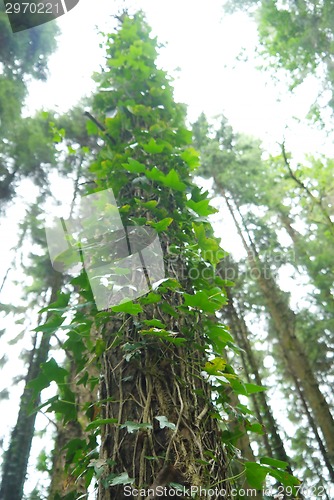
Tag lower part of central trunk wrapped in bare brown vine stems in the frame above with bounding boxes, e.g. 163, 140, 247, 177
99, 268, 229, 500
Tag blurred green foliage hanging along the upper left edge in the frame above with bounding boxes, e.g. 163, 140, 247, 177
0, 4, 58, 207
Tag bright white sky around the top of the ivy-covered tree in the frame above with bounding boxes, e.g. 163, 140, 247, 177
0, 0, 333, 496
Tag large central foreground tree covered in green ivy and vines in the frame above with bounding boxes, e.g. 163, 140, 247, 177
84, 15, 235, 500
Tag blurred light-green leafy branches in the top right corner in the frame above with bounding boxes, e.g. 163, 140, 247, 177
225, 0, 334, 119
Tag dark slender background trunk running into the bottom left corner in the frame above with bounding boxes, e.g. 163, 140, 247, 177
0, 272, 62, 500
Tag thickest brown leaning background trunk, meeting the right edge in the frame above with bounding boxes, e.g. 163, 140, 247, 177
222, 186, 334, 463
